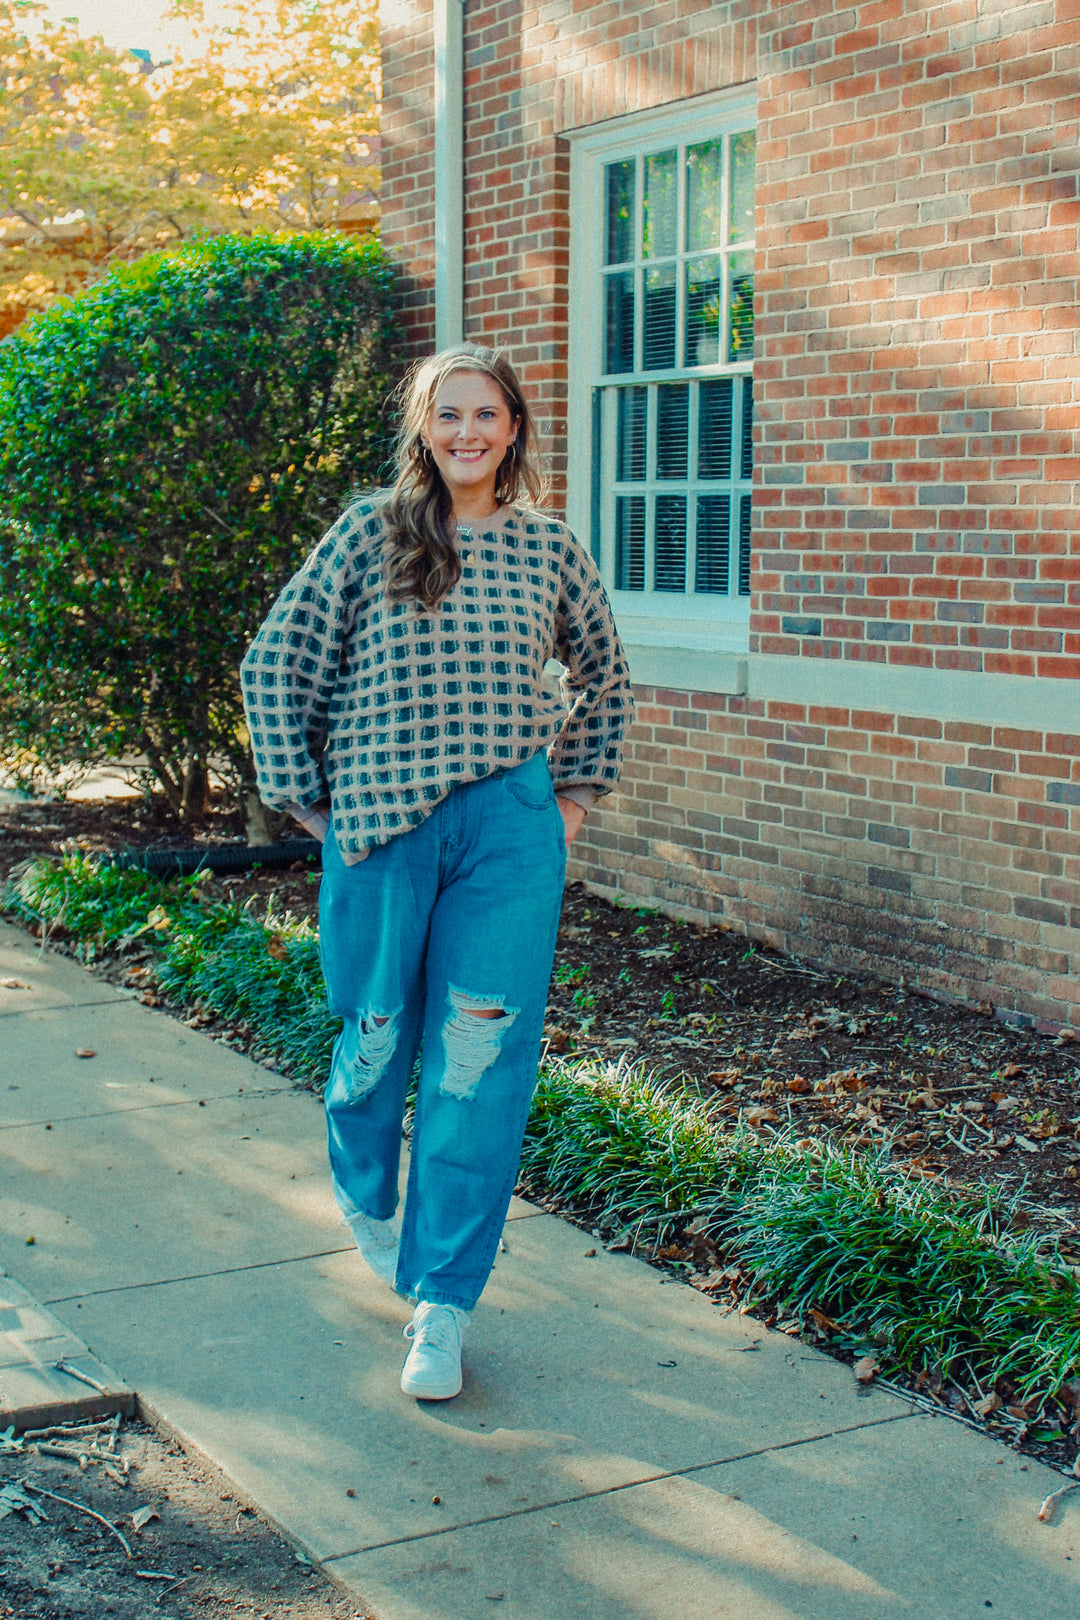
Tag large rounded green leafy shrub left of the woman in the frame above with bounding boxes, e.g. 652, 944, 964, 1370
0, 233, 395, 818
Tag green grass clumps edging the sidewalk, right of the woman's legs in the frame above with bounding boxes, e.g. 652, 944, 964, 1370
523, 1061, 1080, 1393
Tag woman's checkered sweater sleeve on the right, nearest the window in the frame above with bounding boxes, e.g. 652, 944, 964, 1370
551, 535, 633, 794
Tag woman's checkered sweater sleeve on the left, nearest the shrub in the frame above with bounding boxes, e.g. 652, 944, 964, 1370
240, 510, 363, 810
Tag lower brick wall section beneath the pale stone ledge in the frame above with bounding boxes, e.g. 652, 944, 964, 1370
573, 687, 1080, 1024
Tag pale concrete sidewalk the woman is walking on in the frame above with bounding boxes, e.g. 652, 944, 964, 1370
0, 925, 1080, 1620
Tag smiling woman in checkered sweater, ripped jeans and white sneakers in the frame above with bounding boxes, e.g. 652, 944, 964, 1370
241, 343, 631, 1400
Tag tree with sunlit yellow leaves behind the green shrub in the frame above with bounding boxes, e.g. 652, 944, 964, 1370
0, 0, 379, 332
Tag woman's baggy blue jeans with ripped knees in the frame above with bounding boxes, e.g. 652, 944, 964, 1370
319, 753, 567, 1311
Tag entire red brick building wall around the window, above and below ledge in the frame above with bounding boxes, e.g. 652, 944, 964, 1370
384, 0, 1080, 1024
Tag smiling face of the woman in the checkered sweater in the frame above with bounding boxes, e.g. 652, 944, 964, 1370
423, 371, 518, 512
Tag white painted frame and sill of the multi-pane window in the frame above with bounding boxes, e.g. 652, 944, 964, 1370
567, 86, 756, 692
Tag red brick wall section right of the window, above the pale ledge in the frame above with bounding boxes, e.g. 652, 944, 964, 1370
751, 0, 1080, 677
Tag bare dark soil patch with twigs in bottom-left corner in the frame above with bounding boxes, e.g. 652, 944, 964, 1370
0, 1422, 368, 1620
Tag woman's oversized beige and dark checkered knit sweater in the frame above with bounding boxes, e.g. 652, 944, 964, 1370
241, 501, 633, 857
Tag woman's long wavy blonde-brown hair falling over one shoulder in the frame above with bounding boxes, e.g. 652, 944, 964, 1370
385, 343, 542, 612
